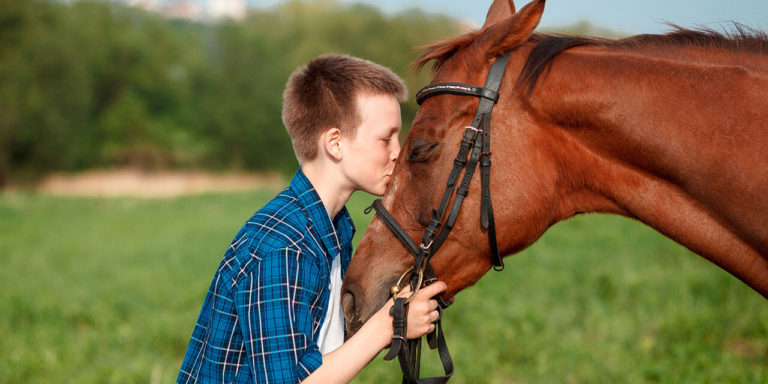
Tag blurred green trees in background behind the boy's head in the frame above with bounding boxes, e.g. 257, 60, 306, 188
0, 0, 461, 187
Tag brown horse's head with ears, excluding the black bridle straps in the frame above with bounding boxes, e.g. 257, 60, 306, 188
342, 0, 551, 334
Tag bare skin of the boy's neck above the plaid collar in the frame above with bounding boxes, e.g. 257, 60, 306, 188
301, 161, 354, 220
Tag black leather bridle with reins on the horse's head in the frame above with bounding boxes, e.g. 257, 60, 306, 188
365, 52, 509, 384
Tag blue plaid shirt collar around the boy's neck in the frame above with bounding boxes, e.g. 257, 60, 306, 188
291, 168, 355, 259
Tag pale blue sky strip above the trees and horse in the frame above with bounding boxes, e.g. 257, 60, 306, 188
248, 0, 768, 34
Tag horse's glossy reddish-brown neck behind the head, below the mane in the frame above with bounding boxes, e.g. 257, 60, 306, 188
531, 45, 768, 297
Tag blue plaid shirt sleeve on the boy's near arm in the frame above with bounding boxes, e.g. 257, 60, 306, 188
235, 248, 322, 384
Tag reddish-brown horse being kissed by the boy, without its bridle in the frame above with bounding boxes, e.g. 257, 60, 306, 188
342, 0, 768, 333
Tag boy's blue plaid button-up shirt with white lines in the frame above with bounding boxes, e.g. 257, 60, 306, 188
177, 170, 355, 384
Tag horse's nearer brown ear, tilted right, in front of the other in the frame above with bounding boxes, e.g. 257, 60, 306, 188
474, 0, 546, 58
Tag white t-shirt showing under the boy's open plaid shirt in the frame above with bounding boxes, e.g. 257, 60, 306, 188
317, 255, 344, 355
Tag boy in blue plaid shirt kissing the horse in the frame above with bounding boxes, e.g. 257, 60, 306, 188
177, 55, 445, 384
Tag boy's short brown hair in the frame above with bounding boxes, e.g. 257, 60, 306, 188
283, 55, 408, 163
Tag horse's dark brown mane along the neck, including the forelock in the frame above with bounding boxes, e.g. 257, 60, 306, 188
413, 23, 768, 95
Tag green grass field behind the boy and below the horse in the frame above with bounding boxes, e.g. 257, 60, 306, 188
0, 191, 768, 384
